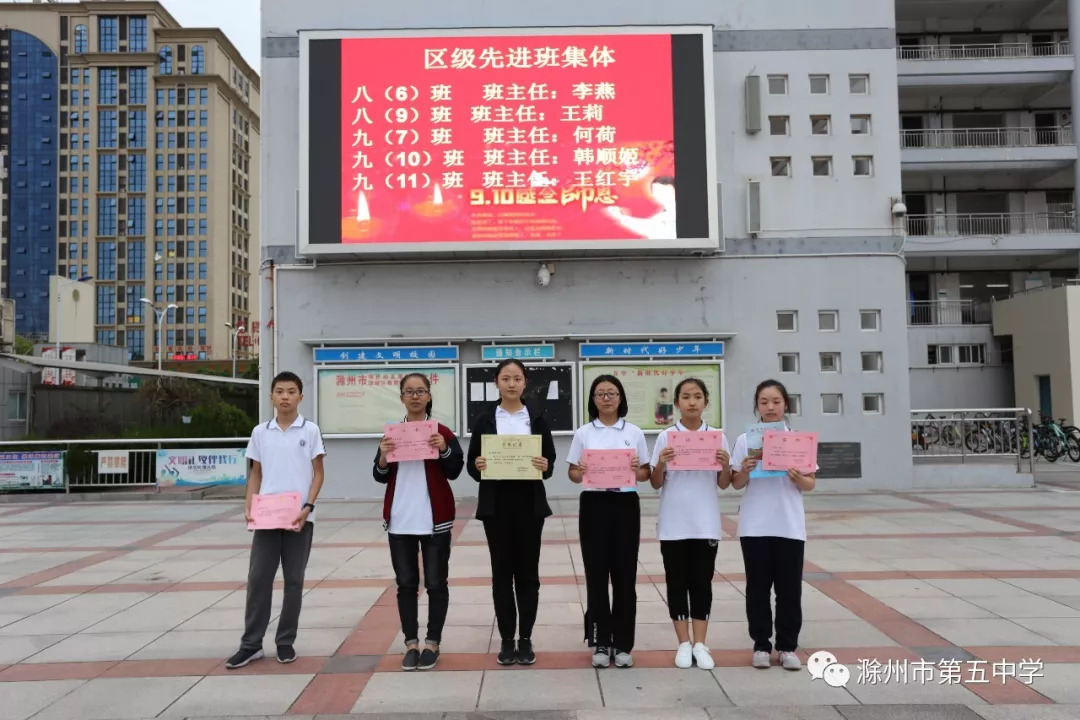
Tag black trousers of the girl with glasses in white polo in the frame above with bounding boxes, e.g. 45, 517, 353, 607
578, 490, 642, 652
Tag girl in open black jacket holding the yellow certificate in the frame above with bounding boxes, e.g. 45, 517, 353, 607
465, 359, 555, 665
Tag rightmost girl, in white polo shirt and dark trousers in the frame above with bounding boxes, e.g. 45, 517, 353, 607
731, 380, 816, 670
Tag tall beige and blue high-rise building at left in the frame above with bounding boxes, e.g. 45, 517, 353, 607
0, 1, 259, 361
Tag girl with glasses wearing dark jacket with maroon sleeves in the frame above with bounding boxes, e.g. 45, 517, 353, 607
373, 372, 464, 670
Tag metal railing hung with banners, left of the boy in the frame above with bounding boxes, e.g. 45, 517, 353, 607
0, 437, 248, 491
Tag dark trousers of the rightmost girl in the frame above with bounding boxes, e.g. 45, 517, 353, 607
739, 538, 806, 652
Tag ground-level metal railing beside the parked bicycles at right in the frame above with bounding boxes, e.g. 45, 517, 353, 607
912, 408, 1035, 472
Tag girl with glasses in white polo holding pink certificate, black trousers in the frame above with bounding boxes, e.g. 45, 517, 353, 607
566, 375, 649, 667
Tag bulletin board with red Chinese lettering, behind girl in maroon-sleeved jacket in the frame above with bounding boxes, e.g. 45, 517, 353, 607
315, 365, 460, 437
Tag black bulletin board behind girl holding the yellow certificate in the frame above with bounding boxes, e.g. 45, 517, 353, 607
461, 363, 578, 435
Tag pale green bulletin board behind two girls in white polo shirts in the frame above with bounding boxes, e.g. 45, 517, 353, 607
581, 361, 725, 433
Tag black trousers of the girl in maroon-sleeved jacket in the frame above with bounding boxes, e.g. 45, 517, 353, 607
390, 532, 450, 644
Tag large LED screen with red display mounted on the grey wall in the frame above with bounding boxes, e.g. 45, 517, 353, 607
300, 26, 720, 255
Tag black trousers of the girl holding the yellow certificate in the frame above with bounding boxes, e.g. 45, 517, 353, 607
484, 512, 543, 640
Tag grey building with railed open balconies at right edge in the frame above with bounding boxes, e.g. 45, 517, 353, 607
895, 0, 1080, 413
